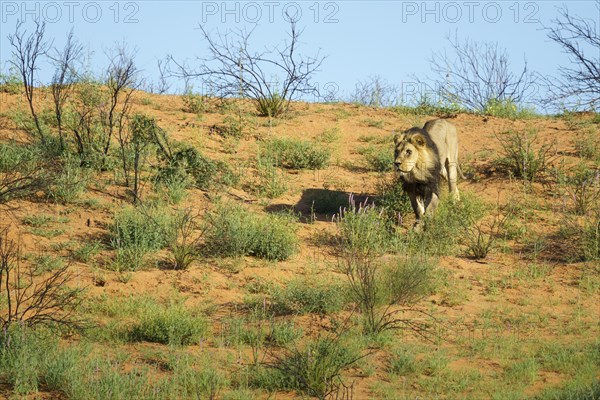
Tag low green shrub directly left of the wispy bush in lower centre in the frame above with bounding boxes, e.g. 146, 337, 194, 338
271, 279, 346, 315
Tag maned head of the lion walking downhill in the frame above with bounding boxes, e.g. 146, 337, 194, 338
394, 128, 439, 182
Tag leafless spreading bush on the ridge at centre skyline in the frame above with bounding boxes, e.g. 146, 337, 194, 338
171, 19, 324, 117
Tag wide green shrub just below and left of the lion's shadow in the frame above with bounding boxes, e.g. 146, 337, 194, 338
205, 202, 298, 261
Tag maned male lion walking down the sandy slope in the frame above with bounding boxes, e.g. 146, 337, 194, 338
394, 119, 464, 228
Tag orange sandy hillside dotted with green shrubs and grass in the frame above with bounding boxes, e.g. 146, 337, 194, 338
0, 88, 600, 399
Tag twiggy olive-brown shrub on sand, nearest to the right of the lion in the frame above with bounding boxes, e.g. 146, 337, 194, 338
496, 130, 553, 182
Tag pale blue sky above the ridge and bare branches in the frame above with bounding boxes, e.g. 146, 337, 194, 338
0, 1, 600, 106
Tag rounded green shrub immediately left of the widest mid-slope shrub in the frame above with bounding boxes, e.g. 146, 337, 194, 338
110, 206, 175, 271
